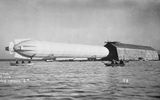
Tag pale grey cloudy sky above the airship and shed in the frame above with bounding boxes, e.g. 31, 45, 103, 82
0, 0, 160, 58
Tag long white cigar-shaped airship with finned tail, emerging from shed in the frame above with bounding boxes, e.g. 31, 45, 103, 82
5, 39, 109, 62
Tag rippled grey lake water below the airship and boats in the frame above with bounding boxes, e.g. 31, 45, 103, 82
0, 62, 160, 100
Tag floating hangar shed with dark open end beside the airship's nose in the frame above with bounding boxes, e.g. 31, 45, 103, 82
103, 42, 159, 60
